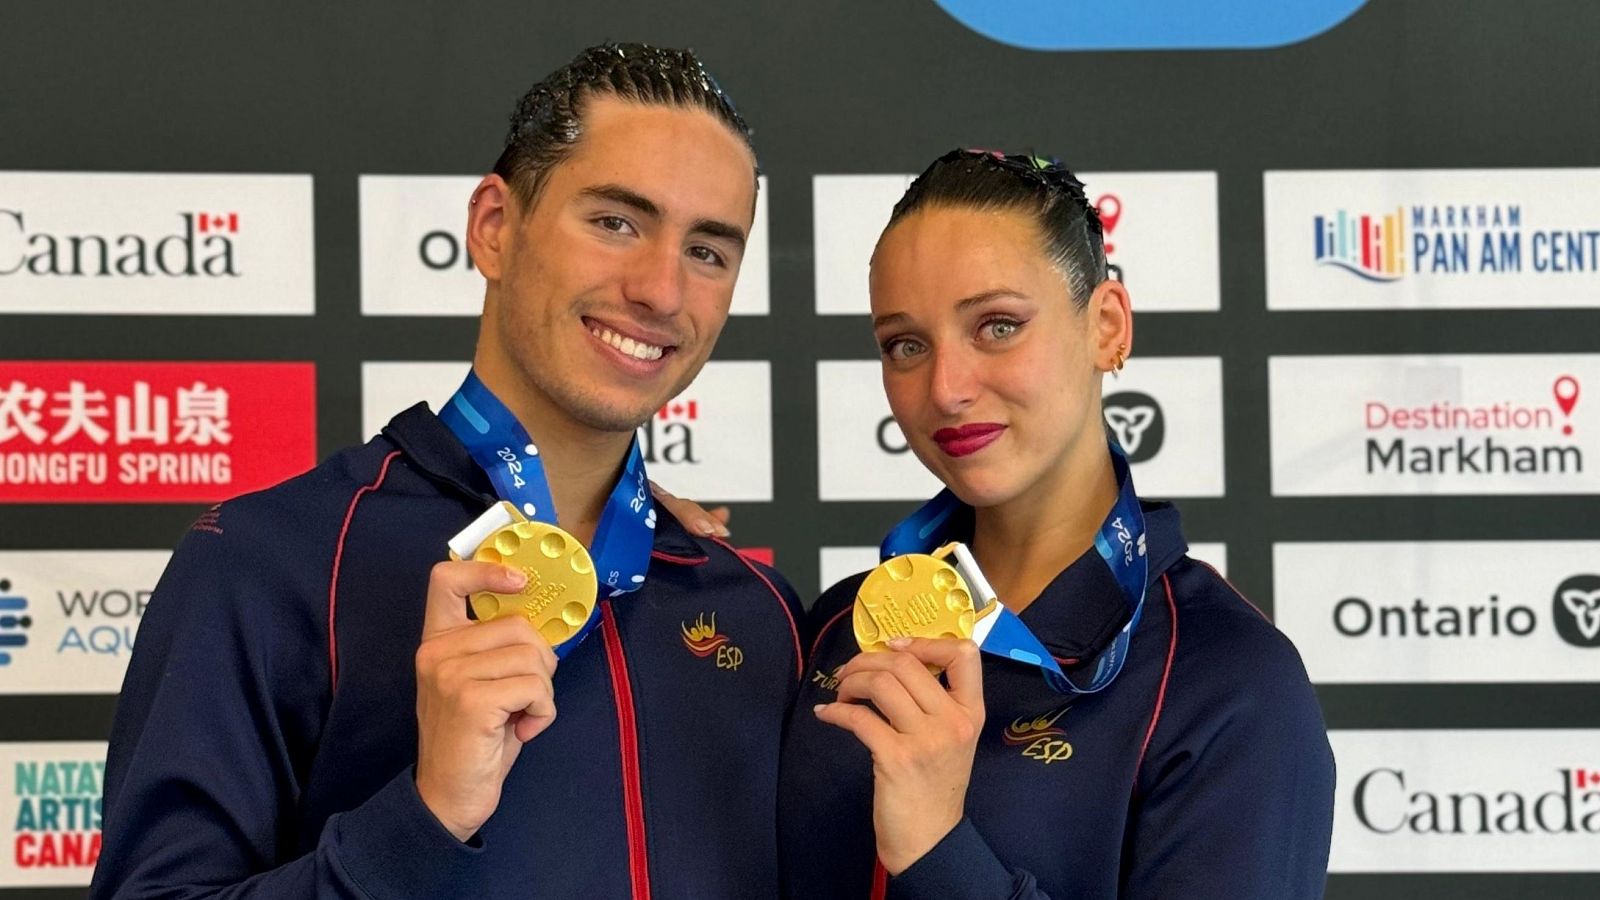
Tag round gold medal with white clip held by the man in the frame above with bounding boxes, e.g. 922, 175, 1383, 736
450, 501, 600, 647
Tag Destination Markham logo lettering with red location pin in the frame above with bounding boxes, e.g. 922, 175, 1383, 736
1362, 375, 1584, 476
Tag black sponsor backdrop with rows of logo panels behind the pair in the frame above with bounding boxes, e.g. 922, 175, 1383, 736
0, 0, 1600, 900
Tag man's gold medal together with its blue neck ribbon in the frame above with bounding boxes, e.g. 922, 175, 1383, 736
438, 372, 656, 658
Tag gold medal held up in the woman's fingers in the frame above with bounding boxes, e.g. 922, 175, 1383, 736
851, 543, 989, 650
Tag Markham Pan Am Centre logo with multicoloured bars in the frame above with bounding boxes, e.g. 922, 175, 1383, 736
1310, 203, 1600, 282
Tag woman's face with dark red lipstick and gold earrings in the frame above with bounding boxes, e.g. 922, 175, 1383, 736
870, 207, 1131, 508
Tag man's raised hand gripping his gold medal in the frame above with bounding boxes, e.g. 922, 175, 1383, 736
416, 562, 555, 841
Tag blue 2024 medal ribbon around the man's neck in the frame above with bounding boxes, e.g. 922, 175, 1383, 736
438, 372, 656, 658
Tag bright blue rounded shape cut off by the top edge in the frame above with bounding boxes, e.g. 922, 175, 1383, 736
934, 0, 1366, 50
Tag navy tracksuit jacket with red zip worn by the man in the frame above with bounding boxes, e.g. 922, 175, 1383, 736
91, 405, 802, 900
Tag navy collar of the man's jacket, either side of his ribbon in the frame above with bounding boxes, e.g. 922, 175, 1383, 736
384, 404, 707, 565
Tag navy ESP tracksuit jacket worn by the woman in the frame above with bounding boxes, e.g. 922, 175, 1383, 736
779, 504, 1333, 900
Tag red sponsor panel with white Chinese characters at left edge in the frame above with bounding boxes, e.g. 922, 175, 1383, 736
0, 360, 317, 503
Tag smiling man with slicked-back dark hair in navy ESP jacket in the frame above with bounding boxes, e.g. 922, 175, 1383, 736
91, 45, 802, 898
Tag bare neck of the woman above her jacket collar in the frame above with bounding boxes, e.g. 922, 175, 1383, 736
973, 444, 1117, 613
